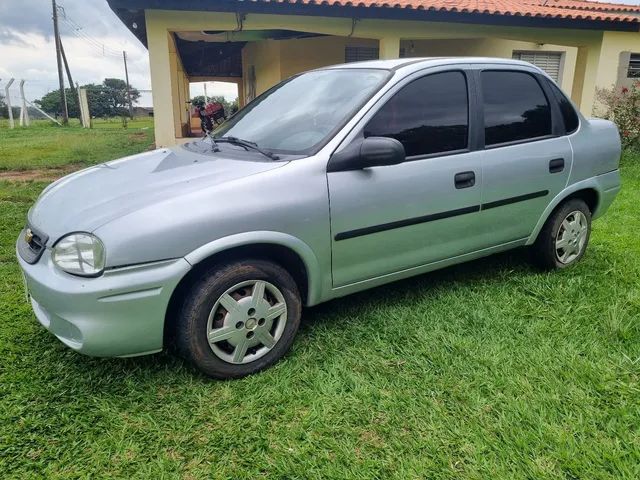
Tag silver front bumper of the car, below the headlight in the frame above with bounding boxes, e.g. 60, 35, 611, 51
18, 249, 191, 357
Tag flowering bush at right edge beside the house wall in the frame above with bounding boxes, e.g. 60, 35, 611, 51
596, 81, 640, 150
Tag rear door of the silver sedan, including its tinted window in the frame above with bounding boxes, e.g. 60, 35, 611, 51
476, 67, 573, 246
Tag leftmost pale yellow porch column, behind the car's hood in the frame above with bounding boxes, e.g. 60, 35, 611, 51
147, 20, 179, 147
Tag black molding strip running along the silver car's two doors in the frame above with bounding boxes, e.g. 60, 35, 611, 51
334, 190, 549, 242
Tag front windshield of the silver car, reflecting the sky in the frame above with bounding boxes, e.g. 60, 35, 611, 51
213, 68, 389, 155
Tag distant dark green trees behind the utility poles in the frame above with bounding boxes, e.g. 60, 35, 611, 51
35, 78, 140, 117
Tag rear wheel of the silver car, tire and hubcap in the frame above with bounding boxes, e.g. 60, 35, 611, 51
531, 198, 591, 270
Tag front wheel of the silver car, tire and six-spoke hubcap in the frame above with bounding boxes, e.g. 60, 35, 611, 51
175, 259, 302, 379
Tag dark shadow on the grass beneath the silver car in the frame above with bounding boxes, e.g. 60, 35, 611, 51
36, 249, 540, 384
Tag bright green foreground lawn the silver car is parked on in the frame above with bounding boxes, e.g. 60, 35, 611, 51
0, 130, 640, 479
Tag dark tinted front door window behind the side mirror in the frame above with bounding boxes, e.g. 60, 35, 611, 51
364, 72, 469, 156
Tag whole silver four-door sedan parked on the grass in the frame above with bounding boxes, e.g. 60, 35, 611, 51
17, 58, 620, 378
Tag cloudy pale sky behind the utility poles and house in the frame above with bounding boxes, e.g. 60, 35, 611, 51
0, 0, 640, 106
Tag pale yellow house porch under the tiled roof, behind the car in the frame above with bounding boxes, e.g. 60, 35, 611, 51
136, 10, 640, 146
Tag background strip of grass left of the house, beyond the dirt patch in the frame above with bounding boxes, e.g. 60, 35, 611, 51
0, 118, 154, 172
